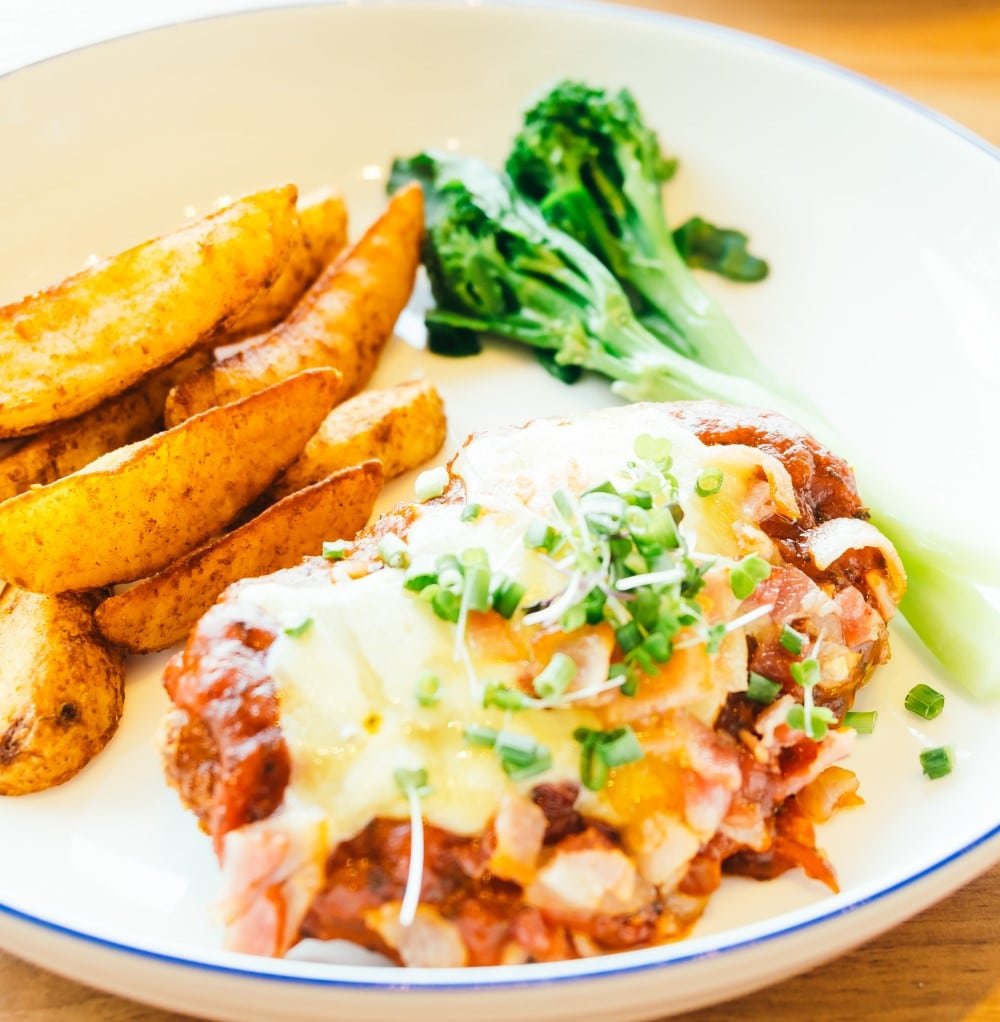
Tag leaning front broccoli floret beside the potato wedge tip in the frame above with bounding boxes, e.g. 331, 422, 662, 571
390, 152, 773, 405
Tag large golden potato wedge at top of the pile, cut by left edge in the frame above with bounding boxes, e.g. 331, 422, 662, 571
0, 185, 299, 436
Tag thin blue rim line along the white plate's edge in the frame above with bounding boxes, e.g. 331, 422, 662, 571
0, 0, 1000, 993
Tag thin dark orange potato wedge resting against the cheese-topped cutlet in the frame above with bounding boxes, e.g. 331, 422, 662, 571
97, 461, 382, 653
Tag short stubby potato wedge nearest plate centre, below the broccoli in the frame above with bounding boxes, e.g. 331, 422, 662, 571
268, 380, 448, 500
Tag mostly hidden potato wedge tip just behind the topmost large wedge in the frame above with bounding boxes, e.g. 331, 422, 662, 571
221, 188, 348, 344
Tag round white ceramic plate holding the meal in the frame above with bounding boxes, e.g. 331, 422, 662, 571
0, 4, 1000, 1022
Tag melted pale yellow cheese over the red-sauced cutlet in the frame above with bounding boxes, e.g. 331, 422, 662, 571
240, 406, 784, 843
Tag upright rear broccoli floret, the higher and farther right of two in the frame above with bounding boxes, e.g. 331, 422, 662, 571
507, 82, 767, 380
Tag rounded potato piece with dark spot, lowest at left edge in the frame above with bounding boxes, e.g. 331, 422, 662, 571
0, 586, 125, 795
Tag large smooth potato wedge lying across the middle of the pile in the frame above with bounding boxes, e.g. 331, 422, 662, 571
0, 369, 339, 593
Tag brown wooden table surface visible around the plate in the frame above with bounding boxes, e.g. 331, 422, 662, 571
0, 0, 1000, 1022
